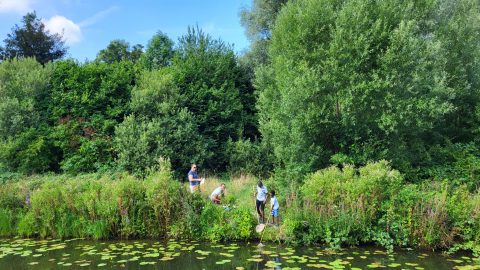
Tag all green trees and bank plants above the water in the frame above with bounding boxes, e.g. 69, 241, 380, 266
0, 0, 480, 258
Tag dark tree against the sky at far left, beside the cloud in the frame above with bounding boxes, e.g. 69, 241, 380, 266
0, 12, 67, 65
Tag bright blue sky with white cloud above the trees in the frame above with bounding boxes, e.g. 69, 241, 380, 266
0, 0, 252, 61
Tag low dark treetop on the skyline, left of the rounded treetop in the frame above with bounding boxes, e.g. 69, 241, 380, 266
96, 39, 143, 64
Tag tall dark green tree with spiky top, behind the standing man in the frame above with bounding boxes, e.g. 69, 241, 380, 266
172, 28, 252, 169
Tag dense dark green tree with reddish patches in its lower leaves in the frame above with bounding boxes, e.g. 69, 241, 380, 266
49, 61, 136, 173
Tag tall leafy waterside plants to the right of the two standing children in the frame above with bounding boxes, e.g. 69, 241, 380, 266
284, 161, 480, 250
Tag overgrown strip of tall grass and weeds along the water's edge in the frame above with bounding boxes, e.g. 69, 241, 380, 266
0, 162, 480, 255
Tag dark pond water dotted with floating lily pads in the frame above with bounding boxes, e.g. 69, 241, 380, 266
0, 239, 480, 270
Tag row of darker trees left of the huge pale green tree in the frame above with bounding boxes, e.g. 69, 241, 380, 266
0, 21, 258, 176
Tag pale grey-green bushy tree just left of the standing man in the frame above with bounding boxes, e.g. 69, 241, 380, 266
115, 70, 211, 176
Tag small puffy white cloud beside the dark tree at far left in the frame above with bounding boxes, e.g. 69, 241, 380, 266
43, 15, 82, 45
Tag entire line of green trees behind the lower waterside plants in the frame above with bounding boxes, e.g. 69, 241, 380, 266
0, 0, 480, 188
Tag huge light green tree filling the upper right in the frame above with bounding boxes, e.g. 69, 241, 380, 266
256, 0, 480, 179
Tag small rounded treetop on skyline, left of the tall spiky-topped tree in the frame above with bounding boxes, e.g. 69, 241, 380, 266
141, 31, 174, 70
